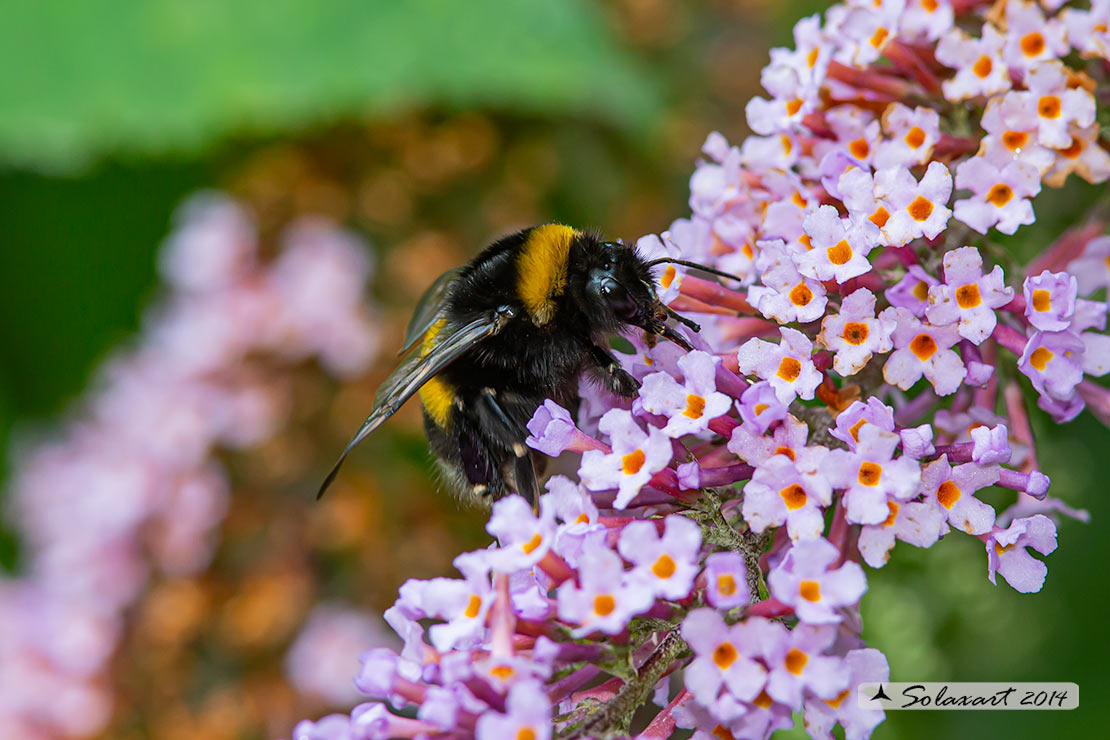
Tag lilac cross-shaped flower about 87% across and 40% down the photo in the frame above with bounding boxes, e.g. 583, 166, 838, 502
925, 246, 1013, 344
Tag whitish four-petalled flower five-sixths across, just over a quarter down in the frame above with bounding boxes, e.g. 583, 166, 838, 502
875, 161, 952, 246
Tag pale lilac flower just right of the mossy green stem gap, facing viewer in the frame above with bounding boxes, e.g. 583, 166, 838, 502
743, 454, 833, 541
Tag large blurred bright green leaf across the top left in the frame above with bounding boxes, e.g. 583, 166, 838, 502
0, 0, 658, 169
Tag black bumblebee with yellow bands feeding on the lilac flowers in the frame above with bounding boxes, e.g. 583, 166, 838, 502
317, 224, 727, 505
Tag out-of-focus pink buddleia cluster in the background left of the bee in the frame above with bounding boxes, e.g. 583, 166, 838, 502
0, 193, 379, 740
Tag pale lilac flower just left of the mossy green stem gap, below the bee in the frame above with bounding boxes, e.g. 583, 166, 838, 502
617, 515, 702, 600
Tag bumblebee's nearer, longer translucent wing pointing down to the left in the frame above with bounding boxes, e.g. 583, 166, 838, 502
316, 306, 515, 499
